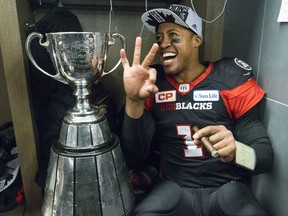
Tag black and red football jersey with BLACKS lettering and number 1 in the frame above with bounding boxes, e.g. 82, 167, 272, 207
145, 58, 264, 187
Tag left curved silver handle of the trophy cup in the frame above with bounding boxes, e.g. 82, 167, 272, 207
25, 32, 68, 84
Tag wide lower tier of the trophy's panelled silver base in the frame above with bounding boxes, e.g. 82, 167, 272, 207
42, 135, 134, 216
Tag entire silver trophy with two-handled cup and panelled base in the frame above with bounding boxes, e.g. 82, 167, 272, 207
25, 32, 134, 216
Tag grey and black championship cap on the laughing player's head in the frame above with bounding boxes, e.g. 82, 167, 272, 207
141, 4, 202, 37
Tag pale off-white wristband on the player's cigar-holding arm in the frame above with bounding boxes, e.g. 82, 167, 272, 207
235, 141, 256, 171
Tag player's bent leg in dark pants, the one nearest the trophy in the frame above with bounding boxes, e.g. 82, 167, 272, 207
134, 180, 192, 216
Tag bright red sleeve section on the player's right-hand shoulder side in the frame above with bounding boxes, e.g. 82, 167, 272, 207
220, 78, 265, 120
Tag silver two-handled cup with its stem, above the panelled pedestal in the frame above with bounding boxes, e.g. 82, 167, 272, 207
25, 32, 125, 123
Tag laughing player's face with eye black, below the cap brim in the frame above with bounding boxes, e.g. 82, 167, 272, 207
156, 23, 199, 76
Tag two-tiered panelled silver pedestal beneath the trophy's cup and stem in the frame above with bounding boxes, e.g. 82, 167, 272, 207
42, 119, 134, 216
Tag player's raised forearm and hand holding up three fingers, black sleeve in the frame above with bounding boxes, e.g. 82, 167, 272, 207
120, 37, 158, 168
